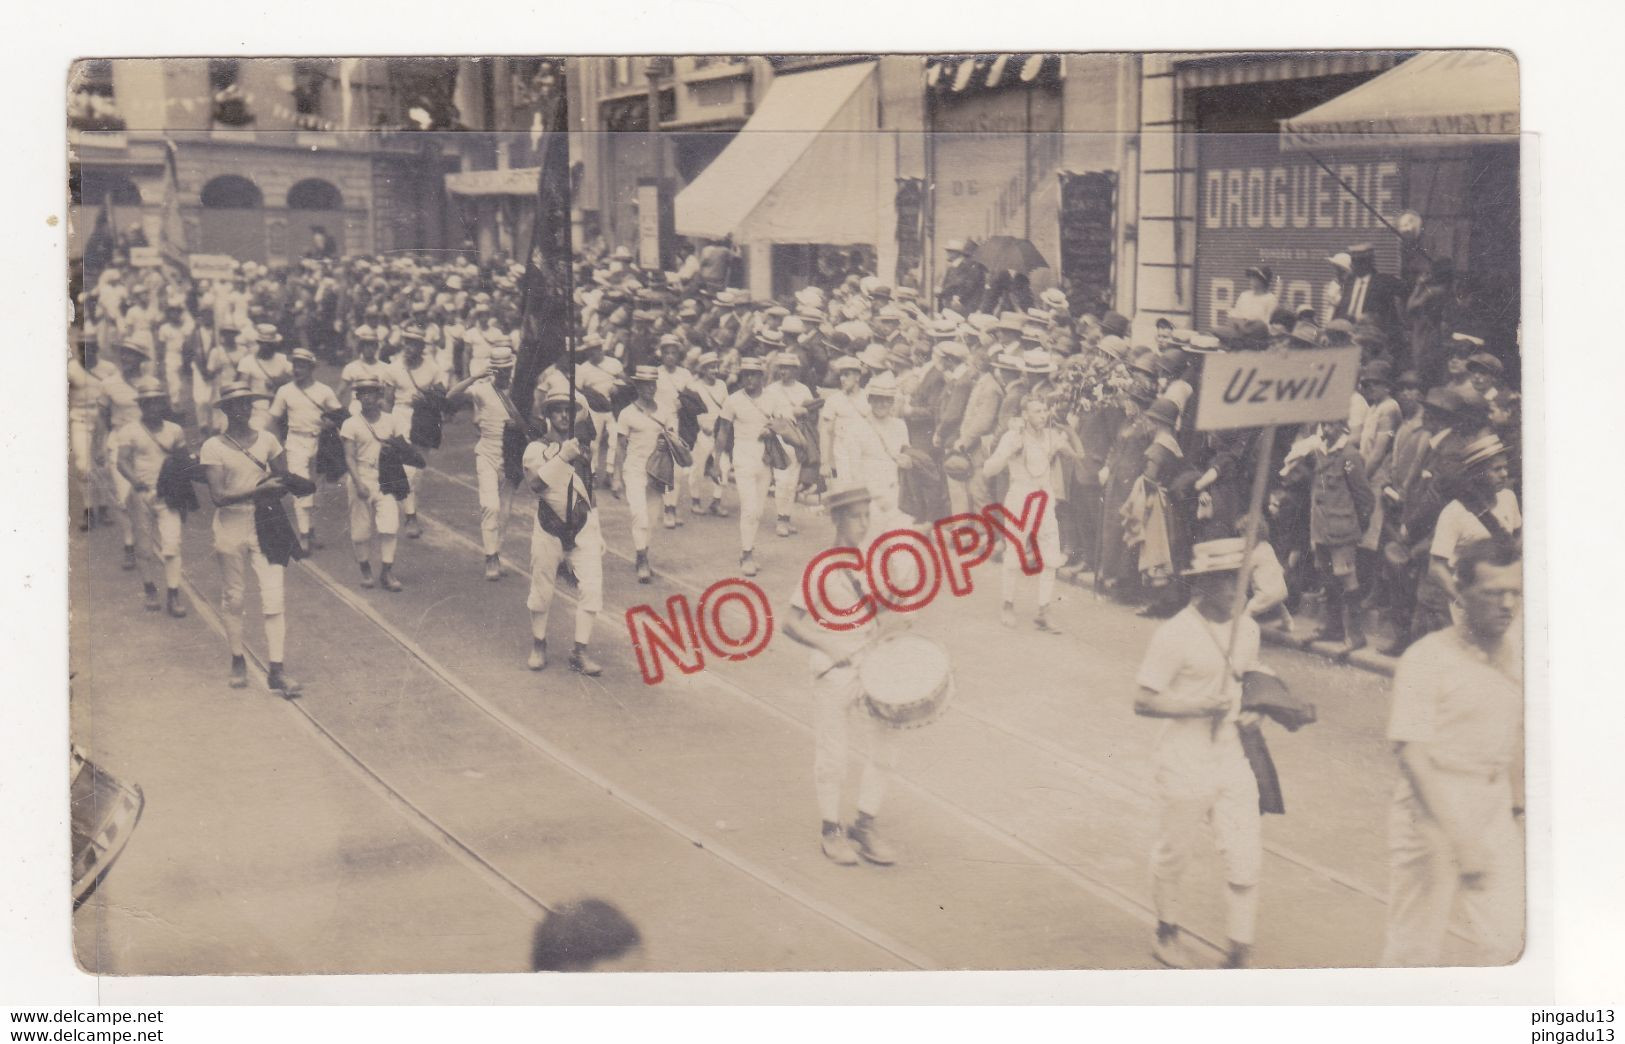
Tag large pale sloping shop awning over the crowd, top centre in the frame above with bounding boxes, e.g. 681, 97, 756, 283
676, 62, 891, 244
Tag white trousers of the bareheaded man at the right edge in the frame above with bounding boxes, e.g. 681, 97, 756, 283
1383, 777, 1524, 968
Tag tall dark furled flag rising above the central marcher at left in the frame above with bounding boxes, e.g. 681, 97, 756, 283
514, 59, 575, 420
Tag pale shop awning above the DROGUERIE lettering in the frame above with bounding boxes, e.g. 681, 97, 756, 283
1281, 50, 1518, 151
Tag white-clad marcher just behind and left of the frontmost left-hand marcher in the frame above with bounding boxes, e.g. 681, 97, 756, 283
114, 377, 187, 616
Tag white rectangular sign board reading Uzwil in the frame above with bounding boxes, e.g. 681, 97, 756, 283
1196, 346, 1360, 431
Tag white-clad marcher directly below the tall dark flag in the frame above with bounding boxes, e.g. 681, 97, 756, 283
525, 392, 605, 678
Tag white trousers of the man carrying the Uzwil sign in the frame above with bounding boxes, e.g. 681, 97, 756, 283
1151, 743, 1264, 943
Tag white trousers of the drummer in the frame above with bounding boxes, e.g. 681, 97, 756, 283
813, 654, 897, 823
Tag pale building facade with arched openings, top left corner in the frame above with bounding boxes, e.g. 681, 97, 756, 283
68, 59, 458, 263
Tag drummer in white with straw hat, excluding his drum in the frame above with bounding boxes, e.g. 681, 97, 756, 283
785, 486, 897, 867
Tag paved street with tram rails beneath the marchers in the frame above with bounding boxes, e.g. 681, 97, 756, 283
73, 393, 1488, 974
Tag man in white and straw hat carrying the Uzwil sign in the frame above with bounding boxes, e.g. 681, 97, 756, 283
1134, 537, 1264, 968
